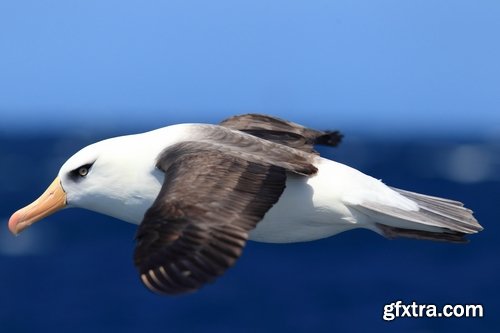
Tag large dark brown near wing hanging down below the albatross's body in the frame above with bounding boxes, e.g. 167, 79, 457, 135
134, 139, 317, 294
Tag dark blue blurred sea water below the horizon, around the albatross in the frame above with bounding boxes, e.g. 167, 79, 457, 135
0, 133, 500, 333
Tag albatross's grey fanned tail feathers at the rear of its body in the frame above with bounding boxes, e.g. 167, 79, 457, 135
357, 188, 483, 243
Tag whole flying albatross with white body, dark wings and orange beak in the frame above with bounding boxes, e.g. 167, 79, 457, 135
8, 114, 482, 294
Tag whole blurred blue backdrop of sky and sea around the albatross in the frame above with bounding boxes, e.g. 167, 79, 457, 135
0, 0, 500, 332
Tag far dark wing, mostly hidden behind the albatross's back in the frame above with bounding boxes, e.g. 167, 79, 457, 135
220, 114, 343, 153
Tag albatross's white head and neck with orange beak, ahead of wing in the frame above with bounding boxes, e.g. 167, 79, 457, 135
9, 136, 163, 234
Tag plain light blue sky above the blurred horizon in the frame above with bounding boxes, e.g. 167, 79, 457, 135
0, 0, 500, 134
